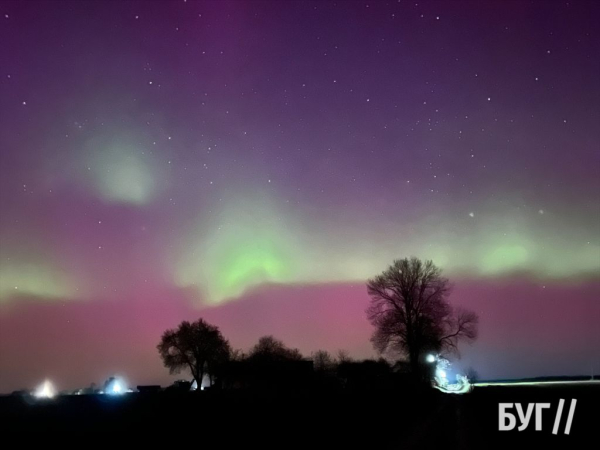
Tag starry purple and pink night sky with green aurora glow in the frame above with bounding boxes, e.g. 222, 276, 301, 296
0, 0, 600, 392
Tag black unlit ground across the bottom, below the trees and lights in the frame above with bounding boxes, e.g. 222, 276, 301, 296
0, 384, 600, 450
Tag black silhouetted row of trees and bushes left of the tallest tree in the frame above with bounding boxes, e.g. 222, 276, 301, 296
158, 319, 408, 389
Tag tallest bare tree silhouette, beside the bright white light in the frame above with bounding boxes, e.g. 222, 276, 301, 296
367, 257, 478, 375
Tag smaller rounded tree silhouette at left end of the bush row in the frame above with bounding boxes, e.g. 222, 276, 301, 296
157, 319, 231, 388
